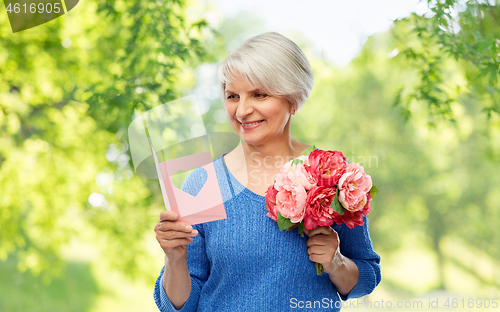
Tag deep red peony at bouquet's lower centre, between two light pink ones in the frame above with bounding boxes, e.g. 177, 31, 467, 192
304, 186, 342, 230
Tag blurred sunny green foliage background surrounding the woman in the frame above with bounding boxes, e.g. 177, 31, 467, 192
0, 0, 500, 311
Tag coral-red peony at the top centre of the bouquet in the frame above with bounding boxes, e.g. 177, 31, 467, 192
309, 150, 347, 187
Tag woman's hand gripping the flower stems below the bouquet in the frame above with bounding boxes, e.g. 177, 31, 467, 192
304, 226, 341, 274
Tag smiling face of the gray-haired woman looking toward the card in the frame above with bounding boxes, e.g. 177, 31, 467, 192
224, 76, 293, 145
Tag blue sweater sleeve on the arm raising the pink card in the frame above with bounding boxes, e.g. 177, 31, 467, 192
154, 169, 210, 312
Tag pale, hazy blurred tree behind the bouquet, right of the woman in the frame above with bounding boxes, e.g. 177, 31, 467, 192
292, 23, 500, 293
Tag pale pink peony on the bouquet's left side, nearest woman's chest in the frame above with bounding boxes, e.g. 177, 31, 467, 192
274, 162, 307, 223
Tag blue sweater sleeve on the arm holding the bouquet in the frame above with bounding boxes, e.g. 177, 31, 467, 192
334, 217, 381, 300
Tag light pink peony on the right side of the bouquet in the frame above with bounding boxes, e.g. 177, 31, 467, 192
338, 163, 372, 212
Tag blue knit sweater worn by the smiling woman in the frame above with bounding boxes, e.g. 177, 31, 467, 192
154, 156, 381, 312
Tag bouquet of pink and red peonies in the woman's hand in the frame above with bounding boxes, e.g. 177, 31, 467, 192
266, 145, 378, 275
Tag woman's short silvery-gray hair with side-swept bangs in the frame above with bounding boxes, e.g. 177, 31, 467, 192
219, 32, 314, 112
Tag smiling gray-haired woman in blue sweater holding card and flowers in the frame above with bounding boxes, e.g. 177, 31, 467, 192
154, 32, 381, 312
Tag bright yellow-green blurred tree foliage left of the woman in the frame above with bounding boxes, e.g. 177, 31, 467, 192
0, 0, 211, 280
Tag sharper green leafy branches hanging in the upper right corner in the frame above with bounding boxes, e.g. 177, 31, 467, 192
393, 0, 500, 127
